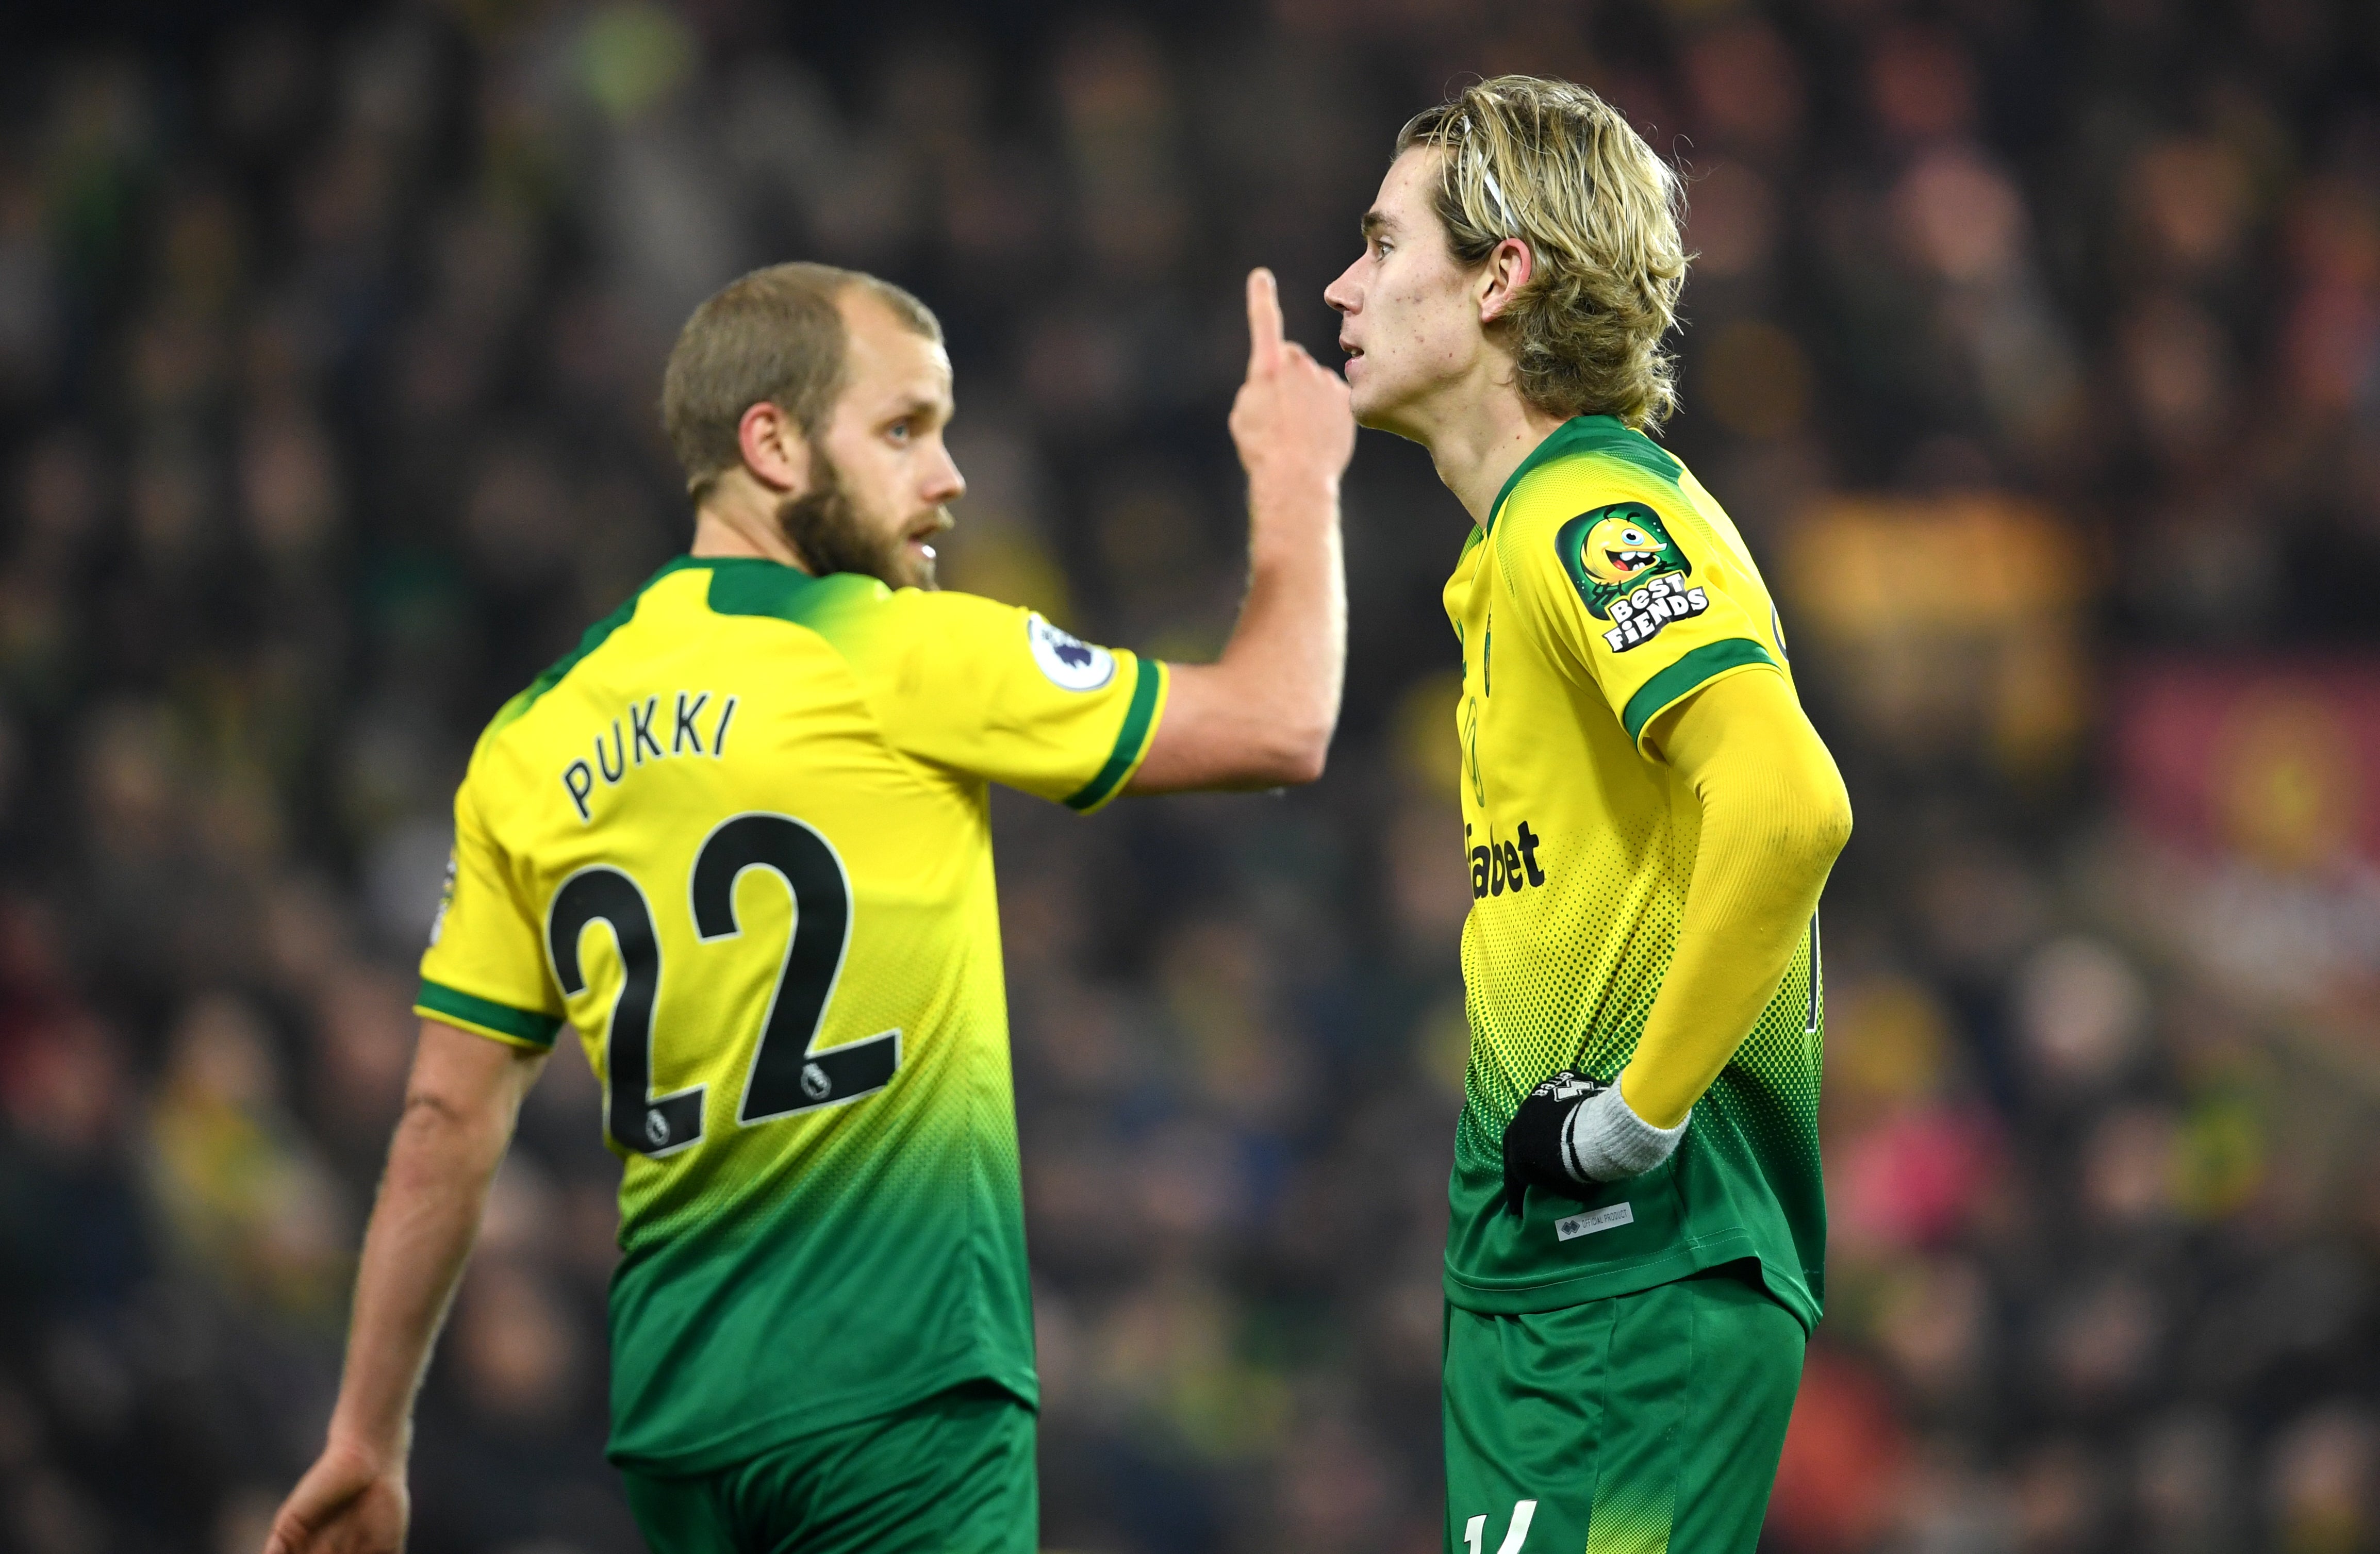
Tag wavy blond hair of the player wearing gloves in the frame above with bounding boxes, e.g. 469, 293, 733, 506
1397, 76, 1688, 428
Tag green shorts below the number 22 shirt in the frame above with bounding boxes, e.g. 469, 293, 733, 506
621, 1383, 1040, 1554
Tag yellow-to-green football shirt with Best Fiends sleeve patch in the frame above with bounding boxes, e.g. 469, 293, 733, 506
1445, 417, 1825, 1323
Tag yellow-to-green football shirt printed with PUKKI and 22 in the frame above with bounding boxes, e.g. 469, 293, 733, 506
417, 557, 1166, 1473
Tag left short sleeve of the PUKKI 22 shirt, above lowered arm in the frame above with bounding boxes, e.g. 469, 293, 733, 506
414, 778, 564, 1052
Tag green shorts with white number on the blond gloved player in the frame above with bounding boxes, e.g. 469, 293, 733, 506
1445, 1271, 1804, 1554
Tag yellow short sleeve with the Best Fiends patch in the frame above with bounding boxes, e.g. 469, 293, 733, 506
1495, 483, 1778, 745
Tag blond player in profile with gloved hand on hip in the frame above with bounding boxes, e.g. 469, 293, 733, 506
1326, 76, 1852, 1554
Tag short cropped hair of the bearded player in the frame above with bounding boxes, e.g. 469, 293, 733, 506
662, 264, 943, 502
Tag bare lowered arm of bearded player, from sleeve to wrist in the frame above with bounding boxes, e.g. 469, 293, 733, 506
331, 1031, 533, 1461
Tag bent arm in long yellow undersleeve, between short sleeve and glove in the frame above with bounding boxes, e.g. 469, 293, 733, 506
1621, 673, 1852, 1128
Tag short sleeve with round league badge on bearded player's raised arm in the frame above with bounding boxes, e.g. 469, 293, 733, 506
878, 592, 1166, 814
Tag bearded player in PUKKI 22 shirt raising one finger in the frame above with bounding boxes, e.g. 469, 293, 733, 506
267, 264, 1354, 1554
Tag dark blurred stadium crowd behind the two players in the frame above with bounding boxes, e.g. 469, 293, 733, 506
0, 0, 2380, 1554
